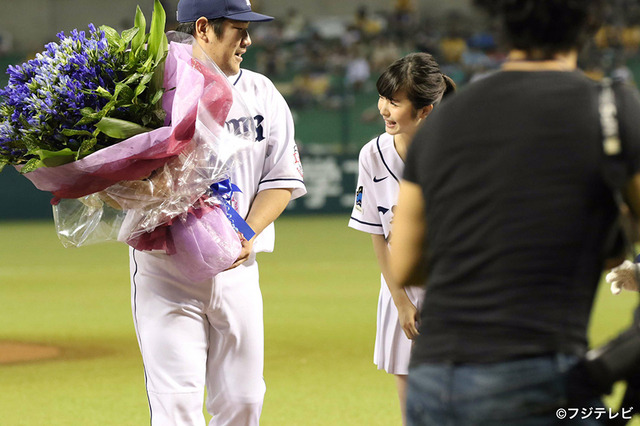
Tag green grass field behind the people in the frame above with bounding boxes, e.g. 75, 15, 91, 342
0, 216, 637, 426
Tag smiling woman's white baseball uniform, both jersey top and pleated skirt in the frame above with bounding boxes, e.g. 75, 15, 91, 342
349, 133, 424, 375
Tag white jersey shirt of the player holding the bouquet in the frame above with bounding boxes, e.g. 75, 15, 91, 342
226, 70, 307, 252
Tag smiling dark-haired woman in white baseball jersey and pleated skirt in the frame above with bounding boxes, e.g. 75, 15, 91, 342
349, 53, 455, 424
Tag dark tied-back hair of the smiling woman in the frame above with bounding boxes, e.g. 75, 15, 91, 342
376, 53, 456, 110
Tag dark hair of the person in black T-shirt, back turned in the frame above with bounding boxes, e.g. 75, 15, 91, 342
475, 0, 605, 60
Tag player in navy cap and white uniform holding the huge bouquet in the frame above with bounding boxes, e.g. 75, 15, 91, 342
130, 0, 306, 426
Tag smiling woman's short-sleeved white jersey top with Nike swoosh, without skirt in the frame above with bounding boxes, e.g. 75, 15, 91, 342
349, 133, 404, 241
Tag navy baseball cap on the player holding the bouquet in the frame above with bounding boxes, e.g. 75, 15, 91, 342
177, 0, 273, 22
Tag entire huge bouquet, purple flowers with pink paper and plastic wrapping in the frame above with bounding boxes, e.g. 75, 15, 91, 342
0, 0, 255, 280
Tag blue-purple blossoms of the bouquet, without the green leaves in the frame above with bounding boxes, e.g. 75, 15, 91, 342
0, 25, 126, 163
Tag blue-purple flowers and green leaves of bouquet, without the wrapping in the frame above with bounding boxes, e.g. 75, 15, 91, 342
0, 0, 168, 172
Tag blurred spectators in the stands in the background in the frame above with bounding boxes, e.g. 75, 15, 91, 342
246, 0, 640, 108
